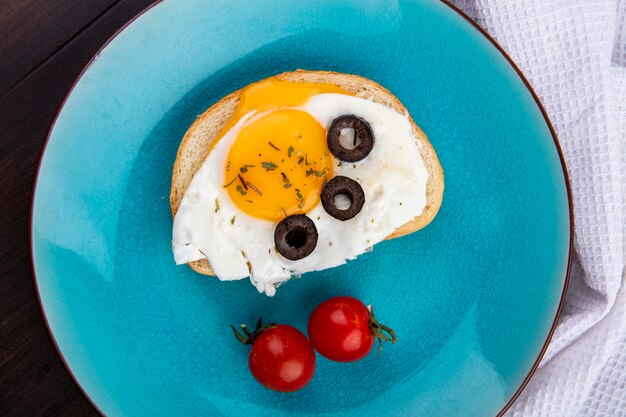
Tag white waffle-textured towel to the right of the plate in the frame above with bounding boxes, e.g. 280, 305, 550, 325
444, 0, 626, 417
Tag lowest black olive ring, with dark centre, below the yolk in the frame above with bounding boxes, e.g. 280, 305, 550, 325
274, 214, 318, 261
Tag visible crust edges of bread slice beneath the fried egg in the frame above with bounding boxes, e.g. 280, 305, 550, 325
170, 70, 444, 275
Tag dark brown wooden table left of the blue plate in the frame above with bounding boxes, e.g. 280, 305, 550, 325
0, 0, 154, 417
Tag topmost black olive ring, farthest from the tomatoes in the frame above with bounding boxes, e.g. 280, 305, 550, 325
326, 115, 374, 162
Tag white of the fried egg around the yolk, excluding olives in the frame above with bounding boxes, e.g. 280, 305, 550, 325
172, 94, 428, 296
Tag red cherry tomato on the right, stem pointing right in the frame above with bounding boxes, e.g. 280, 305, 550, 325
308, 297, 397, 362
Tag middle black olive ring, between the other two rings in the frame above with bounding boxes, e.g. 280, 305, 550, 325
320, 175, 365, 221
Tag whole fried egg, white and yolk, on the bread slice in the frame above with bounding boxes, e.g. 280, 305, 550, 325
172, 78, 428, 296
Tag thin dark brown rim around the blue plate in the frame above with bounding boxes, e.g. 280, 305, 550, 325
28, 0, 574, 417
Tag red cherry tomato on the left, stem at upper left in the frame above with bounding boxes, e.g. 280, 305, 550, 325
233, 324, 315, 392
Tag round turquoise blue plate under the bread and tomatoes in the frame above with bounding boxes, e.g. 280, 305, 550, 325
32, 0, 572, 417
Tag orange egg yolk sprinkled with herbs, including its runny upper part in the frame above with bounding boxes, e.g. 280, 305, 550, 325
222, 78, 350, 222
